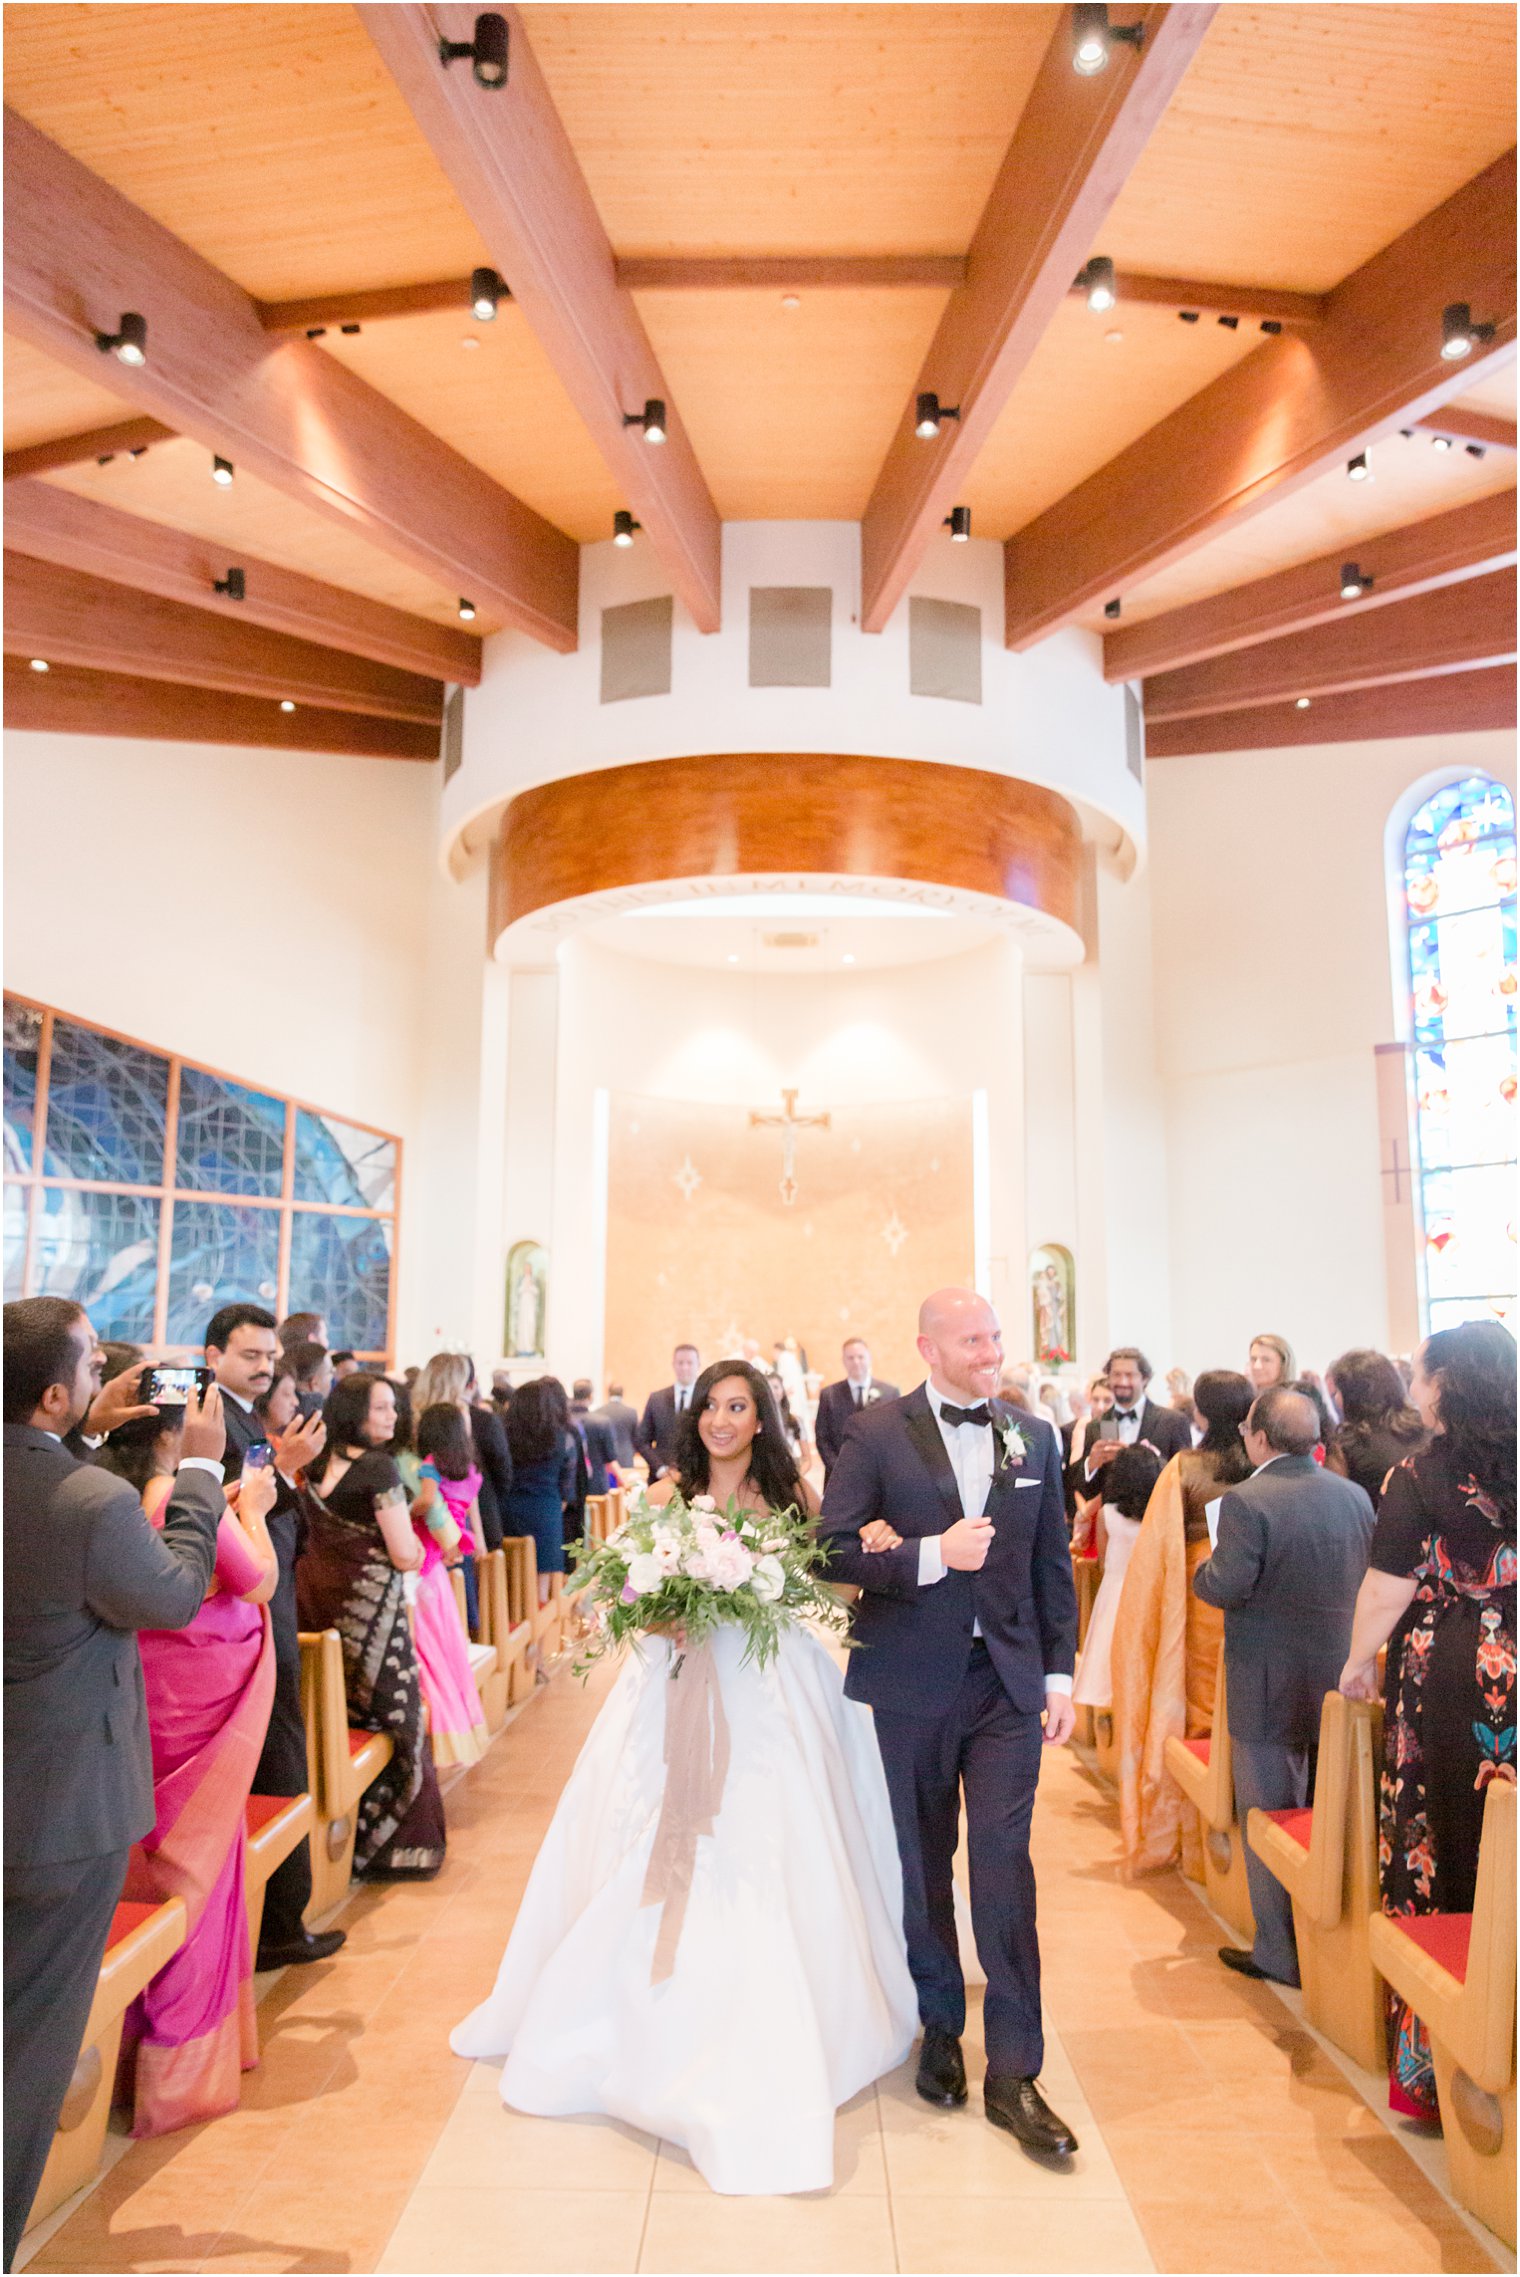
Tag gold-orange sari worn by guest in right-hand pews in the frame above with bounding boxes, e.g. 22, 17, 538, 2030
1113, 1448, 1224, 1881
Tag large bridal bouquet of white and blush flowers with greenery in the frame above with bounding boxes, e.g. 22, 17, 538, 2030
564, 1494, 849, 1674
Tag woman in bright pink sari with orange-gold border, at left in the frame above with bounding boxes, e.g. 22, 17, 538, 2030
100, 1409, 278, 2136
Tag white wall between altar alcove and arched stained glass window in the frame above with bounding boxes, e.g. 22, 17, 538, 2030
1140, 733, 1515, 1368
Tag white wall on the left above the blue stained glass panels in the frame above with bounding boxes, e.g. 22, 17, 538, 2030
5, 733, 505, 1355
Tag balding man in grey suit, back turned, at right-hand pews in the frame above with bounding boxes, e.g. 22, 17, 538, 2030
1192, 1389, 1372, 1986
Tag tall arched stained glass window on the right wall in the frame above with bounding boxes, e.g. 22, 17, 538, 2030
1404, 774, 1515, 1330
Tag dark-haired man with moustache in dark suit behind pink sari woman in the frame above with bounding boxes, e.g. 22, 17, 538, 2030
205, 1305, 348, 1970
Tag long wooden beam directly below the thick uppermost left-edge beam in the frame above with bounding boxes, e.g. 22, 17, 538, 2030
5, 483, 480, 688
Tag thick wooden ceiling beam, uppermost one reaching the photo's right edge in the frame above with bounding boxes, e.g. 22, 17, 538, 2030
1003, 150, 1515, 649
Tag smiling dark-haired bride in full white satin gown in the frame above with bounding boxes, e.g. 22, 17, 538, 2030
451, 1359, 917, 2195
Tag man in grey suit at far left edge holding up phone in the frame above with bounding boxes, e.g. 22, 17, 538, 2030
5, 1296, 225, 2270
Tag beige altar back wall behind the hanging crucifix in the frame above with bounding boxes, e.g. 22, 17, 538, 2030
605, 1093, 972, 1387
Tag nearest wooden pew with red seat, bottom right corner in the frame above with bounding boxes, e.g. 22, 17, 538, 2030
1368, 1778, 1515, 2245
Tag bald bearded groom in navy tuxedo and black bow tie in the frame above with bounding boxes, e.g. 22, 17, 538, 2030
819, 1289, 1076, 2154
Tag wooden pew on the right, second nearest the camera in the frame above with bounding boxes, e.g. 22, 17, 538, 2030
1245, 1692, 1388, 2072
